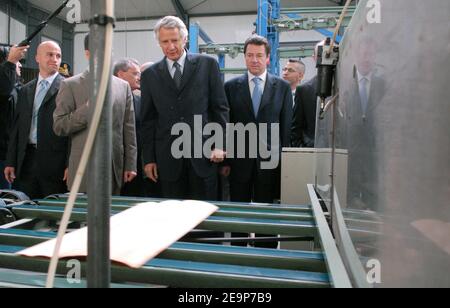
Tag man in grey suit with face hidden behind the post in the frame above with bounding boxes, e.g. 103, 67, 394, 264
53, 36, 137, 195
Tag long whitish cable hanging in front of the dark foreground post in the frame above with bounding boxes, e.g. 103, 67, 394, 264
46, 0, 114, 288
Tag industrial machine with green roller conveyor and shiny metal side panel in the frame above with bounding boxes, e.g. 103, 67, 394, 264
0, 0, 450, 288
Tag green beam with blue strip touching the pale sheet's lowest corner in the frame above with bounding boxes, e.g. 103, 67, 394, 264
0, 250, 330, 289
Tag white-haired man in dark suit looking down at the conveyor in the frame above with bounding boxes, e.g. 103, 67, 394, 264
141, 16, 229, 200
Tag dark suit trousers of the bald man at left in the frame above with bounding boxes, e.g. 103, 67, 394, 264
13, 146, 67, 199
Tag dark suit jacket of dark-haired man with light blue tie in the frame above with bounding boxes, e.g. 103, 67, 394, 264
225, 74, 292, 182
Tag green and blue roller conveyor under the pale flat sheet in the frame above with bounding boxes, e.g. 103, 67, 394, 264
0, 191, 351, 288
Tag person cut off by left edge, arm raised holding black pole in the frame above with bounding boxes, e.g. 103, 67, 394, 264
0, 46, 29, 189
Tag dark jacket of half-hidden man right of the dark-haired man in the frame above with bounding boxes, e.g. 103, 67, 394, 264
291, 76, 317, 148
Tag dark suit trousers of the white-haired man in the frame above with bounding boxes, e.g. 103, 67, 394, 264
161, 159, 218, 201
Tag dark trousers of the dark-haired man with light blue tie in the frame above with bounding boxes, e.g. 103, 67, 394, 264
230, 162, 279, 248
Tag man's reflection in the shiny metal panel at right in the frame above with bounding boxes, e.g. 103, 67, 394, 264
343, 37, 386, 210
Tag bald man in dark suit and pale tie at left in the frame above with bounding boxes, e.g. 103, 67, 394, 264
4, 42, 68, 199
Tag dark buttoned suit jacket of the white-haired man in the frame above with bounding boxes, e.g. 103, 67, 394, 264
141, 53, 229, 182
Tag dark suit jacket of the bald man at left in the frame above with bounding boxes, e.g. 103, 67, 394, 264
6, 75, 68, 180
